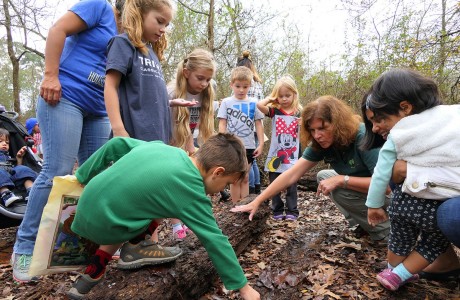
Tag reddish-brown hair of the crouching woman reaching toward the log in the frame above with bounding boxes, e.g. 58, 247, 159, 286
300, 96, 361, 150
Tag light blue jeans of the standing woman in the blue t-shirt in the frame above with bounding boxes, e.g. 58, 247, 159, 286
13, 97, 110, 255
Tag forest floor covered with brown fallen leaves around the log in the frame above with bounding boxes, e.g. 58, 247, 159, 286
0, 191, 460, 300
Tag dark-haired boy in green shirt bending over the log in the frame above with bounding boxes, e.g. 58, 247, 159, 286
68, 134, 260, 299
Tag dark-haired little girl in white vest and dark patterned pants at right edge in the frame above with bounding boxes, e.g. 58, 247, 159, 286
362, 69, 460, 291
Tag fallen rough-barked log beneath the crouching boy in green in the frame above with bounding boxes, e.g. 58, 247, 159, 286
88, 197, 270, 299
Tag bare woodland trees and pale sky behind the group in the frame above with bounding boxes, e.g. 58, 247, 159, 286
0, 0, 460, 121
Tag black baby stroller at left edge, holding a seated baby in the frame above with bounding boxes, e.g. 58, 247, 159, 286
0, 105, 42, 228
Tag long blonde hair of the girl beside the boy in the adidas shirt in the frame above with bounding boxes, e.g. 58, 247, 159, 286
173, 49, 216, 146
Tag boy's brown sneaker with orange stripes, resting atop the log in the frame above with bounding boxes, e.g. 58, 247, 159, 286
117, 235, 182, 269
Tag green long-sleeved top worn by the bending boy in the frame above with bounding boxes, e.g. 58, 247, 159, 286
72, 137, 247, 290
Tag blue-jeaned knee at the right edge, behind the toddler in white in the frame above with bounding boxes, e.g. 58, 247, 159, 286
437, 197, 460, 247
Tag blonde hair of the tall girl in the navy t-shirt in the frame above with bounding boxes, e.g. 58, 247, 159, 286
121, 0, 173, 61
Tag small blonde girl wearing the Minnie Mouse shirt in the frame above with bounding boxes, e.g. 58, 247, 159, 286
257, 76, 302, 221
